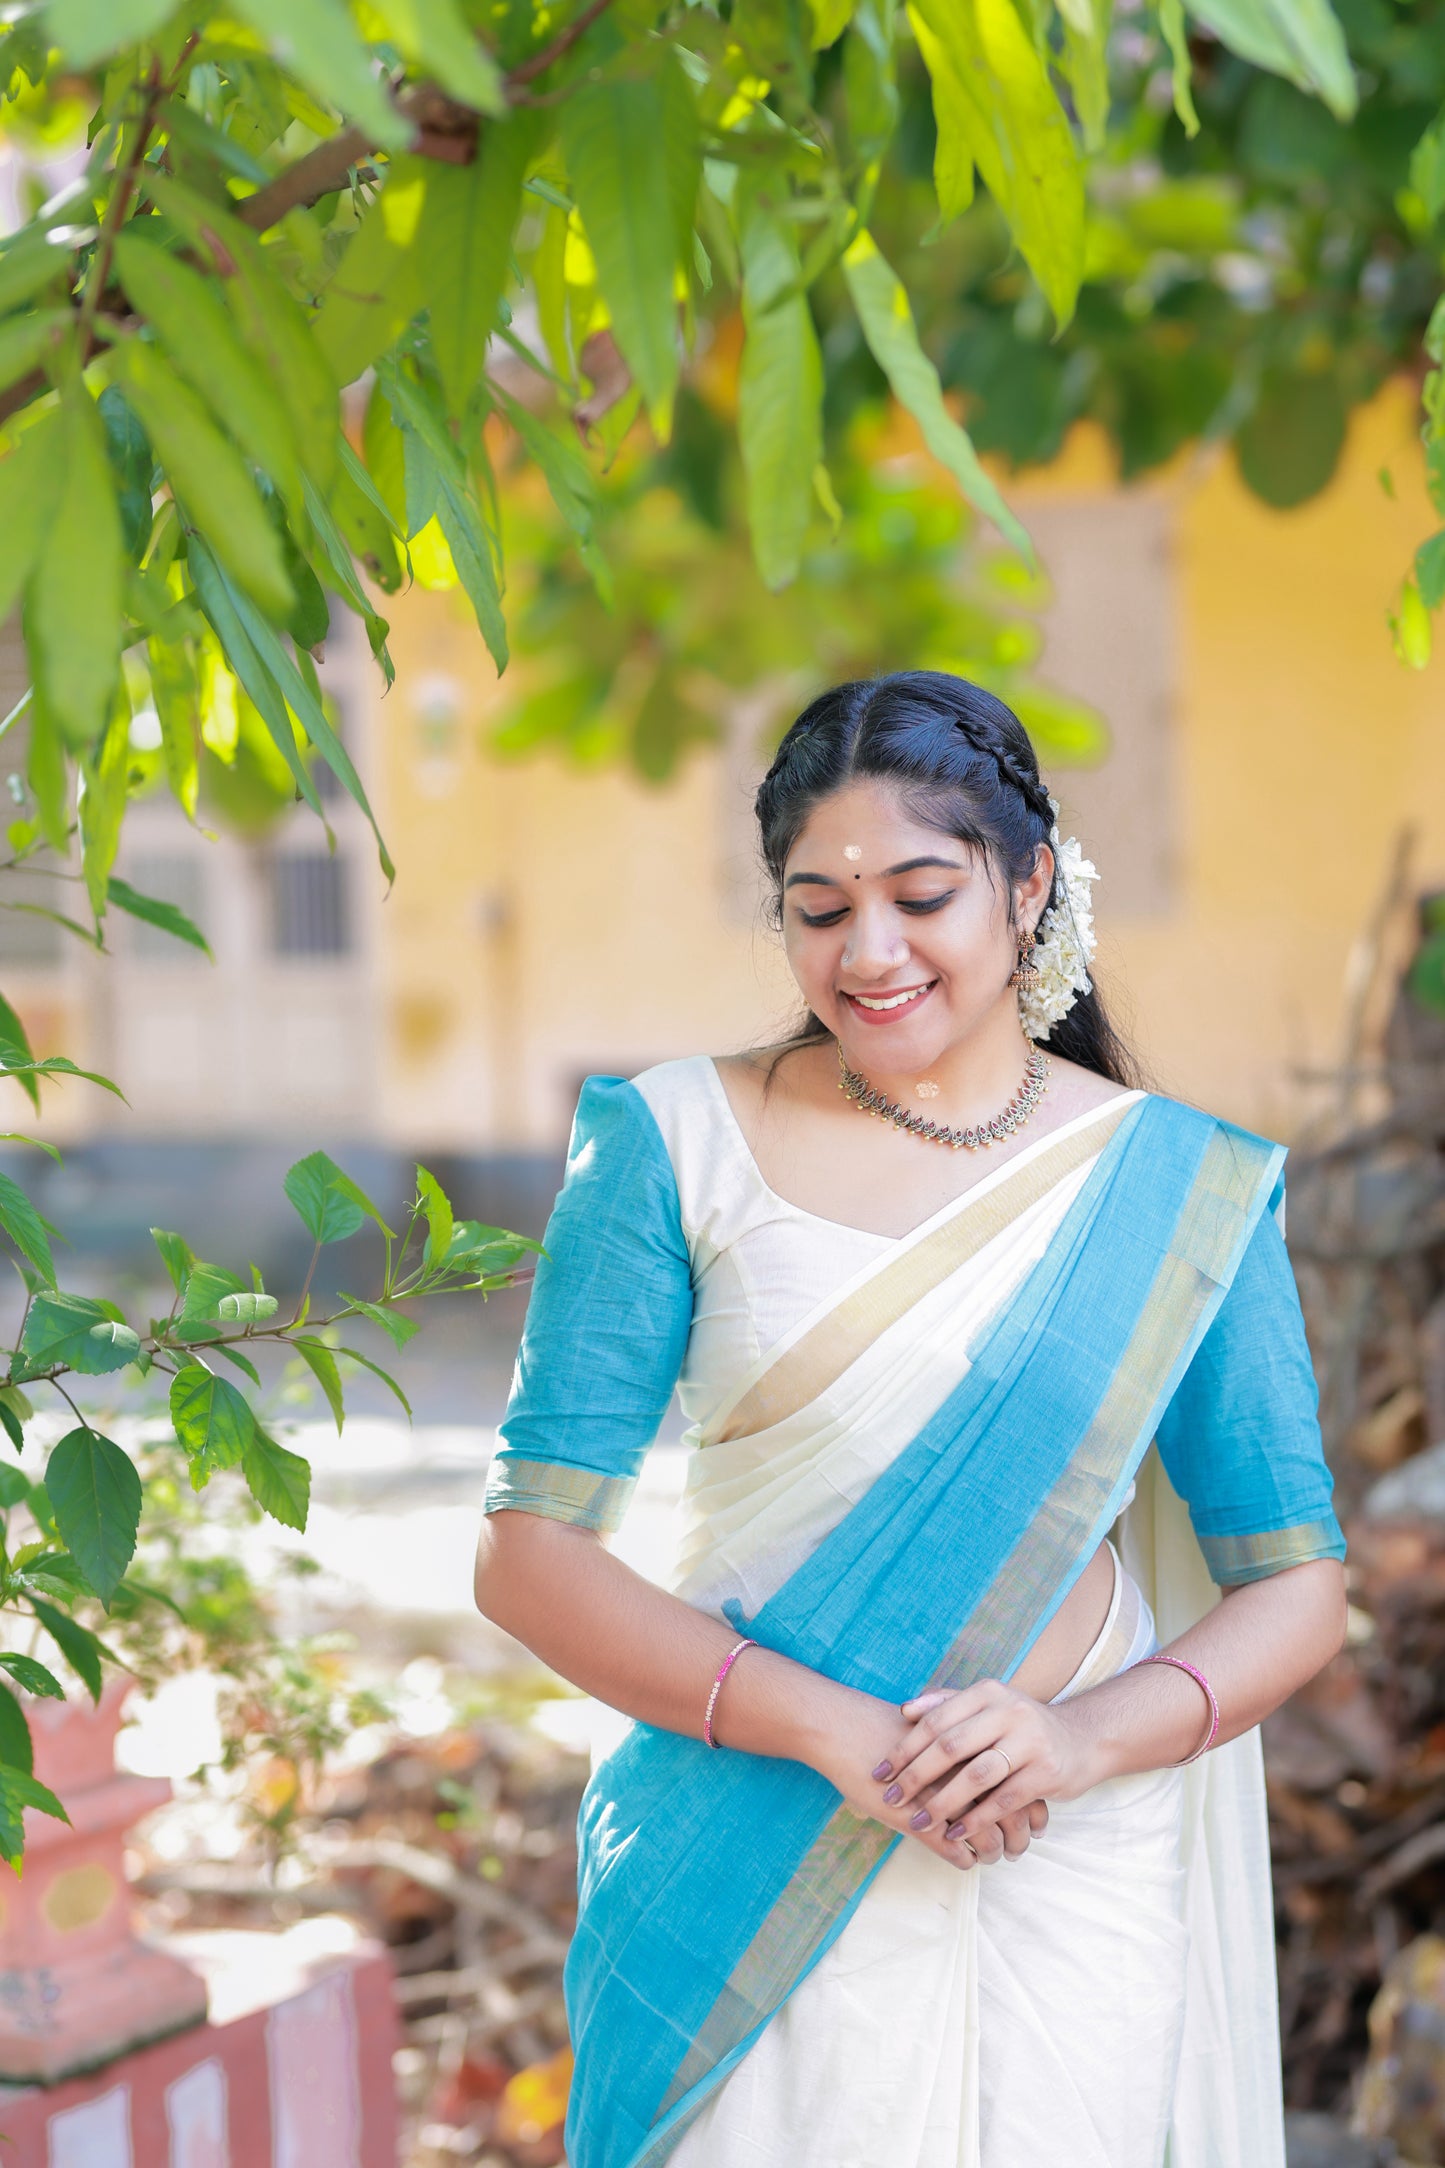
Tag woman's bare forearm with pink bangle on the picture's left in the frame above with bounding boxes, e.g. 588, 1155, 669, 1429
477, 1511, 851, 1763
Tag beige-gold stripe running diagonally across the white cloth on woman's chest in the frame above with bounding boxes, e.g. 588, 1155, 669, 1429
706, 1099, 1140, 1446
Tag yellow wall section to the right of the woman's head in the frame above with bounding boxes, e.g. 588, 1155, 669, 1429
1052, 386, 1445, 1132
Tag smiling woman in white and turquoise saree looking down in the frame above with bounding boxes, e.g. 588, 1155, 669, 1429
477, 672, 1345, 2168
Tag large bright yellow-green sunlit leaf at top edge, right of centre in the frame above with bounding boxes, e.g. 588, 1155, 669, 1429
908, 0, 1083, 325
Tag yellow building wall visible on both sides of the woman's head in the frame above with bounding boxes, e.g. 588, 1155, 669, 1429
375, 386, 1445, 1149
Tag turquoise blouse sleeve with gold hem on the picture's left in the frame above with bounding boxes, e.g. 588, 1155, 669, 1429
485, 1077, 693, 1531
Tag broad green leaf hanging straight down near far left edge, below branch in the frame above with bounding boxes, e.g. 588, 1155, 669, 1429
26, 388, 123, 746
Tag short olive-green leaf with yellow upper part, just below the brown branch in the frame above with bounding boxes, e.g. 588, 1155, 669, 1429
314, 156, 433, 384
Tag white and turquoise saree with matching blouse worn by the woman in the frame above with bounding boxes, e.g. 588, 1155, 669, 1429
487, 1058, 1343, 2168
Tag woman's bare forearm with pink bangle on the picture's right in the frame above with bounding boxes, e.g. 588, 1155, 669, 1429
1059, 1559, 1345, 1782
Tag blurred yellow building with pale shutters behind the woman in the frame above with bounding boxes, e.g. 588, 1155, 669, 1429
11, 386, 1445, 1257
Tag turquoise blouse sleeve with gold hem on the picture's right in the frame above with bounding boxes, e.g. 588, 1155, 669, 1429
1157, 1210, 1345, 1587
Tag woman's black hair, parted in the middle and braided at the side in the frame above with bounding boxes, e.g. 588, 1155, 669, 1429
754, 670, 1137, 1086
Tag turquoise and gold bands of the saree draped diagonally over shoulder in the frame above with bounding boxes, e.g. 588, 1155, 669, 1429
568, 1097, 1285, 2168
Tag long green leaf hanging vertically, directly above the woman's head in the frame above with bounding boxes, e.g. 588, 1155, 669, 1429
737, 206, 823, 588
